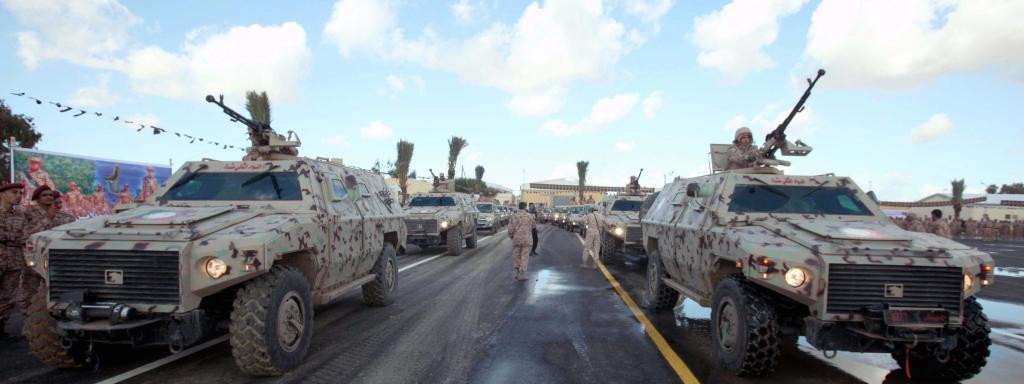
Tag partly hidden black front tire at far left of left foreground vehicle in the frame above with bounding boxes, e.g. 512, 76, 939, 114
22, 285, 85, 369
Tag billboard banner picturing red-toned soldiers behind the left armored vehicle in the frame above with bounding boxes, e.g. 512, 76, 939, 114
13, 147, 171, 217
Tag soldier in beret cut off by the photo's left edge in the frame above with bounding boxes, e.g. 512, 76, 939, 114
0, 183, 28, 339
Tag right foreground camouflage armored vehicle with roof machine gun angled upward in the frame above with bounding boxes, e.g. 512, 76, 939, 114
642, 70, 993, 381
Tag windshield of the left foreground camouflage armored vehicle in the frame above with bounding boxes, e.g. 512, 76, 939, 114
164, 172, 302, 201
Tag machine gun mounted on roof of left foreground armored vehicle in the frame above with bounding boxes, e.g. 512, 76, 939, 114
206, 93, 302, 161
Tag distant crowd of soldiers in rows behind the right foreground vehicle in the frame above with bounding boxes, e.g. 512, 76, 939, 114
893, 210, 1024, 241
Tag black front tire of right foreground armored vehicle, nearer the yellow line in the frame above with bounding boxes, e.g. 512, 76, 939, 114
711, 275, 782, 377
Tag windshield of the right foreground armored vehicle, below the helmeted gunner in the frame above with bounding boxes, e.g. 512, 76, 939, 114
729, 184, 871, 216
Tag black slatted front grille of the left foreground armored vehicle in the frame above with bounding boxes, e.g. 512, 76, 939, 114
49, 250, 181, 304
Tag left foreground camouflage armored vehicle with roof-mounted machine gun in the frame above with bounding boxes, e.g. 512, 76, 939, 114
25, 96, 406, 376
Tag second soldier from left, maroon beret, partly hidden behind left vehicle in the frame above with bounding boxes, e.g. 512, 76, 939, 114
18, 185, 75, 313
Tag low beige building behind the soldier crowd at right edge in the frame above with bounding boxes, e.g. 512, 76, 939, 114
879, 194, 1024, 220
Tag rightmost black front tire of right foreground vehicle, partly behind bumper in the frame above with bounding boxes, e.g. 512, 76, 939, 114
892, 297, 992, 382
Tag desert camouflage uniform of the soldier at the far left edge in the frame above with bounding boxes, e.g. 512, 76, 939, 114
0, 208, 28, 327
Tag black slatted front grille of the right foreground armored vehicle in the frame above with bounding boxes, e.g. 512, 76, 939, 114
827, 264, 964, 317
